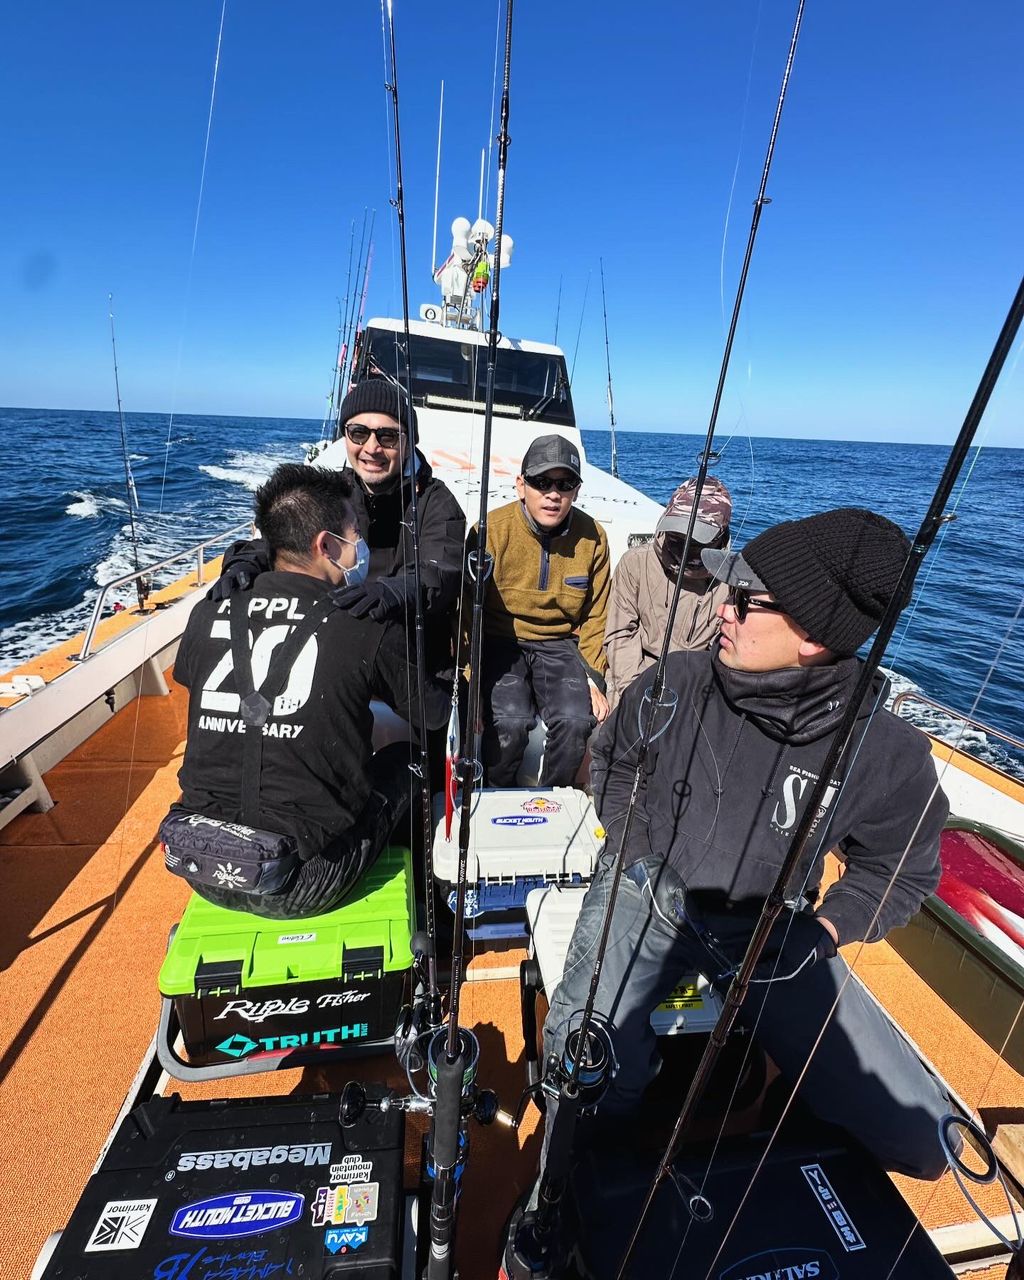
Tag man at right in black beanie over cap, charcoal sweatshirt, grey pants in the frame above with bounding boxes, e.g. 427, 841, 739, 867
544, 508, 952, 1178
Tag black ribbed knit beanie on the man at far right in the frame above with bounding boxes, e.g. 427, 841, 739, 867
742, 507, 910, 657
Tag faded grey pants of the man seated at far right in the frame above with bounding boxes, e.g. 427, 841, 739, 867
544, 852, 952, 1179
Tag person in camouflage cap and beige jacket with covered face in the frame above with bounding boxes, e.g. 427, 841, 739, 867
604, 476, 732, 708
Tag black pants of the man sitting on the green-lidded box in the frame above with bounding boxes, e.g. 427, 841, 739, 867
192, 742, 411, 920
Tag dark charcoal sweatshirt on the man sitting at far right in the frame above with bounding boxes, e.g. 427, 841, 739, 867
591, 653, 948, 942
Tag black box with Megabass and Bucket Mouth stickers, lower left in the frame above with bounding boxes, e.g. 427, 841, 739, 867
42, 1088, 404, 1280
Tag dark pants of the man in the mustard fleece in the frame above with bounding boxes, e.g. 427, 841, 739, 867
483, 637, 596, 787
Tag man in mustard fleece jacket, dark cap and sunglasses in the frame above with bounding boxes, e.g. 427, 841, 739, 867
468, 435, 611, 787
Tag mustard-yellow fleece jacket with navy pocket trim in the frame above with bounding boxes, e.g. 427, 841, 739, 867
463, 500, 611, 675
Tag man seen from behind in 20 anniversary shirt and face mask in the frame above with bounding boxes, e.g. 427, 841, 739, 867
167, 463, 448, 919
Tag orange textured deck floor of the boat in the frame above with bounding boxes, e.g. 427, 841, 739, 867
0, 665, 1024, 1280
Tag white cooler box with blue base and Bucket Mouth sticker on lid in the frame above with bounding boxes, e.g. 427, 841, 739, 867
434, 787, 604, 938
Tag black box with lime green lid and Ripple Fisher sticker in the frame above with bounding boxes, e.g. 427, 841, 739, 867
157, 847, 416, 1079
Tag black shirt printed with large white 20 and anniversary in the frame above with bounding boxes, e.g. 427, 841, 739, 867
174, 572, 448, 858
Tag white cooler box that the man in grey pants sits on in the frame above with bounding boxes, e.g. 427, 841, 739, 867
526, 887, 722, 1036
